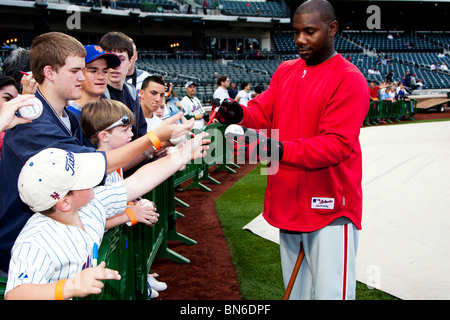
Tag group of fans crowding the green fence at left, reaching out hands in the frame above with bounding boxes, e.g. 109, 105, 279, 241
0, 32, 213, 299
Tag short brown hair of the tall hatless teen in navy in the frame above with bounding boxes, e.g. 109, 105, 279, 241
30, 32, 86, 84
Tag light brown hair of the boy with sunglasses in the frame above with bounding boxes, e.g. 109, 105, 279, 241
81, 99, 136, 146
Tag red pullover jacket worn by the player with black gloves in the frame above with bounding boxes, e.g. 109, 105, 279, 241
241, 54, 370, 232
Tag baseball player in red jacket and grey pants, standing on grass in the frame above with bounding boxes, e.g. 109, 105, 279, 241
218, 0, 370, 299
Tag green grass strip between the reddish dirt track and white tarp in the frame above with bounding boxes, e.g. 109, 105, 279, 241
215, 165, 397, 300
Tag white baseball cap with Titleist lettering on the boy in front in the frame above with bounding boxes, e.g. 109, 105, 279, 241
17, 148, 106, 211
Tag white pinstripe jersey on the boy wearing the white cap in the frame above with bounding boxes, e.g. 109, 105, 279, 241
5, 181, 127, 294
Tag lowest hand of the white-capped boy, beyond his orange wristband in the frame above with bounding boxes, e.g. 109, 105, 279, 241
63, 261, 120, 299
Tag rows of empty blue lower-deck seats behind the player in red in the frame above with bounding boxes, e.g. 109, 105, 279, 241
133, 31, 450, 103
